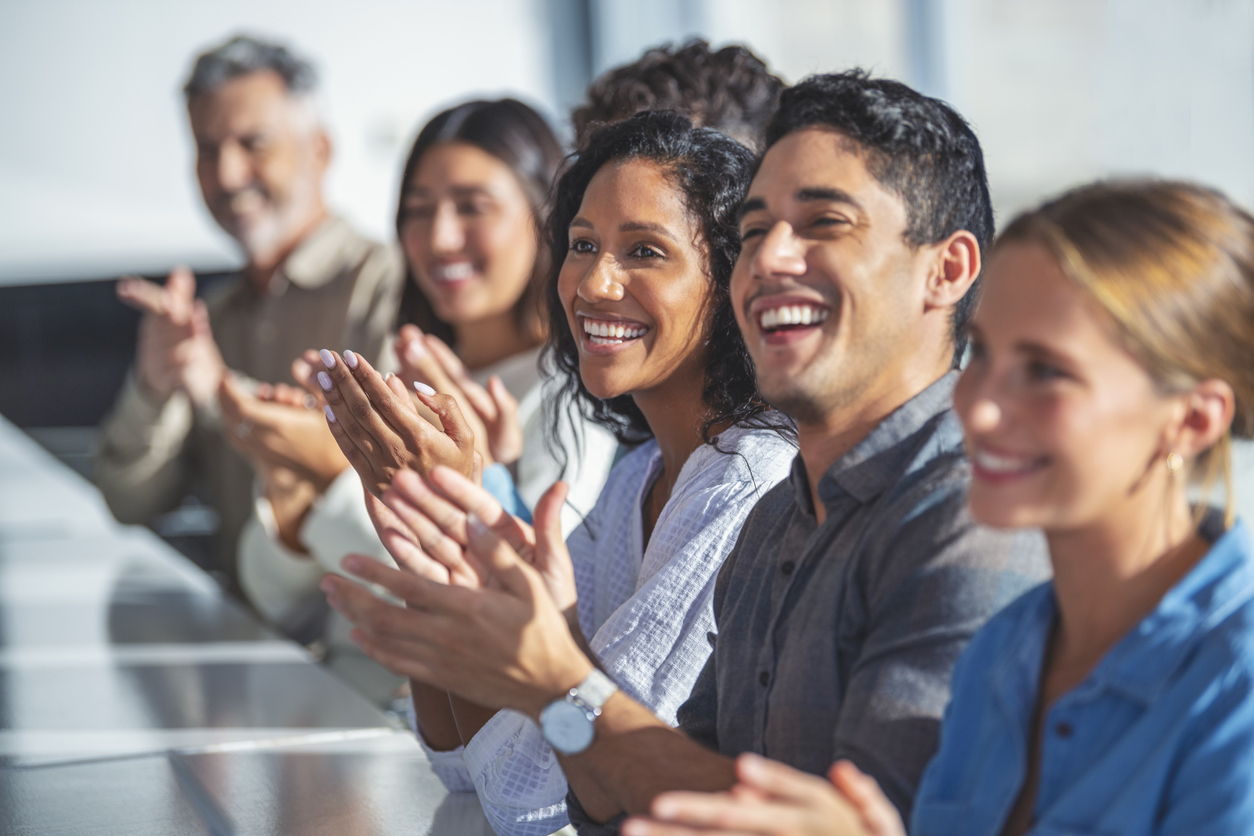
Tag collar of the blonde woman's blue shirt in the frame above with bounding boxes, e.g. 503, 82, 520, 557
1081, 511, 1254, 704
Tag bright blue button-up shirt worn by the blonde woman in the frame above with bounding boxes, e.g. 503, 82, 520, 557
910, 514, 1254, 836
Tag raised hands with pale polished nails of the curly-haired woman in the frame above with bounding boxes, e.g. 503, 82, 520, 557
316, 348, 475, 496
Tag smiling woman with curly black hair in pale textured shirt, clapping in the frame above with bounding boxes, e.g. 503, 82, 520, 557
318, 113, 795, 835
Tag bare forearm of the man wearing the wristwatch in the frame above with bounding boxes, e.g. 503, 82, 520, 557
559, 692, 736, 821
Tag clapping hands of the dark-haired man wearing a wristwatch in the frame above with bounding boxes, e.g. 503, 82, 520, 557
322, 469, 581, 717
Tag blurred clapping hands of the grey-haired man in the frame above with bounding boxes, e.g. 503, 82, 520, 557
118, 267, 226, 406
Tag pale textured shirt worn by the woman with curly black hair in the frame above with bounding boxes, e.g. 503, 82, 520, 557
453, 431, 791, 836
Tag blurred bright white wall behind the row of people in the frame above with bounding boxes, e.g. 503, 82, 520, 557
0, 0, 1254, 282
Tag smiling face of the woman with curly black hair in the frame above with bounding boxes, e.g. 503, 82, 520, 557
558, 159, 712, 399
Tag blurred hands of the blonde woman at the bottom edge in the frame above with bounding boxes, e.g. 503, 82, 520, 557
622, 755, 905, 836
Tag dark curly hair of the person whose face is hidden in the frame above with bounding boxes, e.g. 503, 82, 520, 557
571, 38, 784, 150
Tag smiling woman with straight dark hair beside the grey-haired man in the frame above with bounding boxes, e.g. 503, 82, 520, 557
226, 99, 618, 667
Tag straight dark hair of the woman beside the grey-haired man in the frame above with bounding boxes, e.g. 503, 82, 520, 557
396, 99, 562, 346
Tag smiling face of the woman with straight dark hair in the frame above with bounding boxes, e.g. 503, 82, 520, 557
400, 143, 538, 325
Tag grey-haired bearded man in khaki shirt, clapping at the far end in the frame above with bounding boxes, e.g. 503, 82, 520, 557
95, 36, 401, 589
